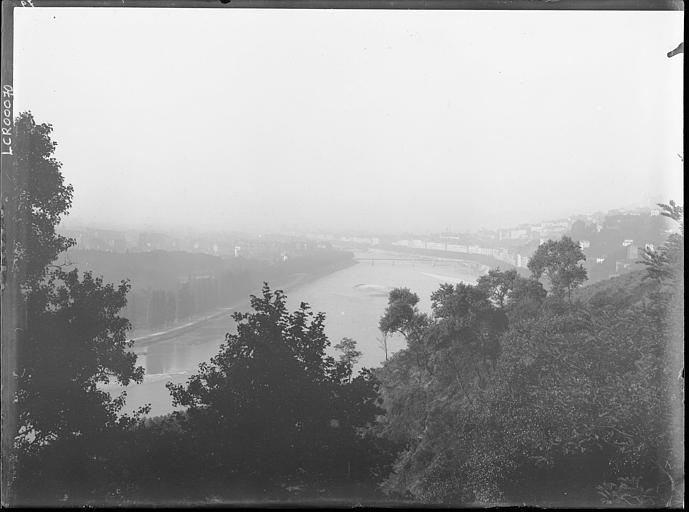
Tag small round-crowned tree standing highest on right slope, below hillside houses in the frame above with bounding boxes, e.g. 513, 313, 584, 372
528, 236, 587, 300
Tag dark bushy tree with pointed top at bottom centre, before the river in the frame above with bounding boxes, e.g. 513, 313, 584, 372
168, 284, 392, 492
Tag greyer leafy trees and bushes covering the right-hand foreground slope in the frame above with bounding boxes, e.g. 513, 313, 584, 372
378, 222, 683, 506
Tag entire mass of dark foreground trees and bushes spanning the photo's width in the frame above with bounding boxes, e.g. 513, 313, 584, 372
3, 113, 684, 506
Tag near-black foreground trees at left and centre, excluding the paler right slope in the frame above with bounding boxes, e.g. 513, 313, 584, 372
8, 109, 394, 505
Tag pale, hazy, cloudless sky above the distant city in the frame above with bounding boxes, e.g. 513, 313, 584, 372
14, 8, 684, 235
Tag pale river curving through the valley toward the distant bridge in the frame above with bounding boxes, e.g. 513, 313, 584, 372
106, 250, 480, 416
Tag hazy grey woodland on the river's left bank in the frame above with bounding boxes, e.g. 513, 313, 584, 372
65, 248, 352, 331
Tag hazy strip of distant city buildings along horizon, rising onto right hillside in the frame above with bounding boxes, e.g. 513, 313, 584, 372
60, 204, 678, 282
